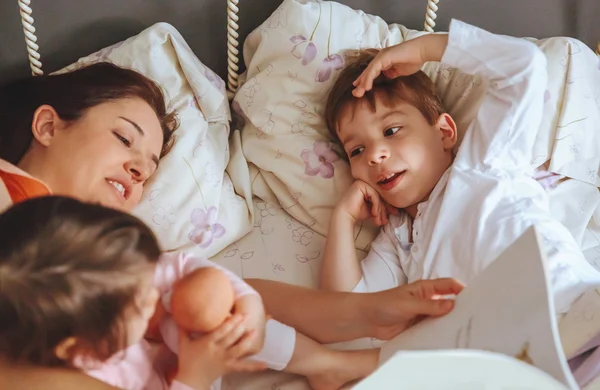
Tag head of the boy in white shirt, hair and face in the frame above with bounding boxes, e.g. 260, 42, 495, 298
325, 49, 457, 213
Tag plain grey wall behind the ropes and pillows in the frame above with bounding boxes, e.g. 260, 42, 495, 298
0, 0, 600, 84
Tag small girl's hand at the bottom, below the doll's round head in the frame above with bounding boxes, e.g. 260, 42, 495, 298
175, 315, 264, 390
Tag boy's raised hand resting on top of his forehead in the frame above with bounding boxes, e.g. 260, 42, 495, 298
352, 34, 448, 97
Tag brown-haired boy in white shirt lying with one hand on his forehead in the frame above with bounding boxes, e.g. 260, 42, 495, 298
321, 20, 600, 314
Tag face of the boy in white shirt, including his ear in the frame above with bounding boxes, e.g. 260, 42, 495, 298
338, 98, 456, 209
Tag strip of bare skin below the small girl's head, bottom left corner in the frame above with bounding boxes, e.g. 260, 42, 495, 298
0, 365, 117, 390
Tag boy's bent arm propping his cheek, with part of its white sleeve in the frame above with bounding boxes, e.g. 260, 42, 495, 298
320, 180, 405, 291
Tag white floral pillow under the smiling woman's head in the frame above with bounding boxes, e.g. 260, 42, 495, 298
63, 23, 253, 256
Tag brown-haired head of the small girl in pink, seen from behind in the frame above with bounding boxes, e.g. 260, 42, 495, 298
0, 197, 160, 366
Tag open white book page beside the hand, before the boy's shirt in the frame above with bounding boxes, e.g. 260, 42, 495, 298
380, 227, 578, 388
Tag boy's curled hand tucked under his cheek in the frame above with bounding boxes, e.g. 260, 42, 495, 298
335, 180, 388, 226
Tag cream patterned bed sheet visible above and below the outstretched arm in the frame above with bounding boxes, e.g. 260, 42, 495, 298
211, 197, 342, 390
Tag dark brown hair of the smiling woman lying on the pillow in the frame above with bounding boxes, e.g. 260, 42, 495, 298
0, 62, 178, 165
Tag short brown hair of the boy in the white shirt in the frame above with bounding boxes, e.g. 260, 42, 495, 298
325, 49, 446, 140
